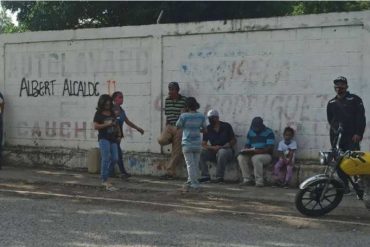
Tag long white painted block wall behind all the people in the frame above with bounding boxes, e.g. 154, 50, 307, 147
0, 11, 370, 170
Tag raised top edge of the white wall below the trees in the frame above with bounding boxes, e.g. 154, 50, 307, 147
0, 11, 370, 44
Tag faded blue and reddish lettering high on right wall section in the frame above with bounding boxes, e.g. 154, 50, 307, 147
180, 42, 291, 90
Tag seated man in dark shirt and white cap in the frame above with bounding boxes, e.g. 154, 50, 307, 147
199, 110, 236, 183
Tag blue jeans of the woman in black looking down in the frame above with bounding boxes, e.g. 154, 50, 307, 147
99, 139, 118, 182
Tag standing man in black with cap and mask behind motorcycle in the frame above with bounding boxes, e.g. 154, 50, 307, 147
326, 76, 366, 193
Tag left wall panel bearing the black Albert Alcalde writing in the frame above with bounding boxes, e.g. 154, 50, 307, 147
1, 38, 158, 151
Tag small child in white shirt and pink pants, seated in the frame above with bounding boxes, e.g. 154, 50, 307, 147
274, 127, 297, 188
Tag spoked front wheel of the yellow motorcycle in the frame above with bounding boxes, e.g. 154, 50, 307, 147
295, 179, 344, 217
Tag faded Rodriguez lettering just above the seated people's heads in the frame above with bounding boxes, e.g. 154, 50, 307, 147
201, 94, 331, 134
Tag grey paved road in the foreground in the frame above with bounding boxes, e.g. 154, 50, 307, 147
0, 180, 370, 247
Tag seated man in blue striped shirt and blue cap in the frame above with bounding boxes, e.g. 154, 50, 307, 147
238, 117, 275, 187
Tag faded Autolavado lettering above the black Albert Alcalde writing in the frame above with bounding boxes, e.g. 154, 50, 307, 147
6, 48, 150, 80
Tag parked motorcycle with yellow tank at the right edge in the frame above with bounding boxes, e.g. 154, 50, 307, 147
295, 126, 370, 217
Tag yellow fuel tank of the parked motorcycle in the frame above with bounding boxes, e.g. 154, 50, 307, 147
340, 152, 370, 176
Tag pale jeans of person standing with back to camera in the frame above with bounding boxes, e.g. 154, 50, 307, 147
182, 148, 200, 188
